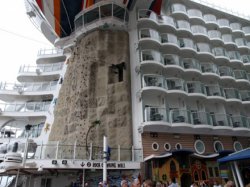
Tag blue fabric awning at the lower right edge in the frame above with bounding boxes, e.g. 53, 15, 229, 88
218, 148, 250, 162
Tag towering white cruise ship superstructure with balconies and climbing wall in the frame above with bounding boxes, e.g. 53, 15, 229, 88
0, 0, 250, 187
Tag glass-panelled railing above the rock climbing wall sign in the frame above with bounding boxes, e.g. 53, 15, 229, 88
26, 142, 142, 161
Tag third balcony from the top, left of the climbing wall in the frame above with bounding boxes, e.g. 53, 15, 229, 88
0, 81, 58, 101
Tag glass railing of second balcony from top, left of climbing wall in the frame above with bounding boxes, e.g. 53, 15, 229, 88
19, 63, 63, 73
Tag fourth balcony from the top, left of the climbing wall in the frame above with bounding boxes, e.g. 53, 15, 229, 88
0, 101, 51, 117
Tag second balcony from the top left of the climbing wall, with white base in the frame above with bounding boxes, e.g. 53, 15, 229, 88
17, 63, 63, 82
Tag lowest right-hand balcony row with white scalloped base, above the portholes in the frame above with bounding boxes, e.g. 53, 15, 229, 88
142, 105, 250, 136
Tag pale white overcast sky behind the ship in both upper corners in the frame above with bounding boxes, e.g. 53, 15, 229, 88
0, 0, 250, 82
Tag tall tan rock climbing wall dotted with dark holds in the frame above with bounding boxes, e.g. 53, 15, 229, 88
49, 30, 132, 159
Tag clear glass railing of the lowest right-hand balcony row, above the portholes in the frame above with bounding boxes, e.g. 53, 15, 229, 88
144, 106, 250, 128
